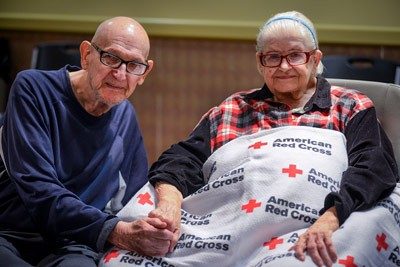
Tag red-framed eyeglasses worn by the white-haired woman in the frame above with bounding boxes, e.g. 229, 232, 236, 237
259, 49, 315, 68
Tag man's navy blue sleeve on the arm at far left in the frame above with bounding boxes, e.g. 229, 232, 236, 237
1, 73, 115, 249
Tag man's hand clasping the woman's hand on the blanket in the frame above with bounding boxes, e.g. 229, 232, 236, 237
108, 218, 174, 256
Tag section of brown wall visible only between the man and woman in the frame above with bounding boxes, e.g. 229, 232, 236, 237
132, 38, 261, 161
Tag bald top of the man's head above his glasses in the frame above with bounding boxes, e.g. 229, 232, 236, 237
92, 17, 150, 58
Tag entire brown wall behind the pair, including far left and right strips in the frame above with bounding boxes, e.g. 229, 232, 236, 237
0, 31, 400, 162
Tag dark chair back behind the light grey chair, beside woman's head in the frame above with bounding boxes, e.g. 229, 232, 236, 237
322, 55, 400, 83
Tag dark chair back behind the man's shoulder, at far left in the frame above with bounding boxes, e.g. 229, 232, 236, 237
31, 42, 81, 70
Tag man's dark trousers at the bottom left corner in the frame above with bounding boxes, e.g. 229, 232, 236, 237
0, 231, 100, 267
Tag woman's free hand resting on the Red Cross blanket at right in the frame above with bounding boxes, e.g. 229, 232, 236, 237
290, 207, 339, 266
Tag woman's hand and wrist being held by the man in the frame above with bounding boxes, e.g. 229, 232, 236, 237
148, 183, 183, 252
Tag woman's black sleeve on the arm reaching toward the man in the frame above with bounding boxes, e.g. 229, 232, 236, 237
149, 118, 211, 197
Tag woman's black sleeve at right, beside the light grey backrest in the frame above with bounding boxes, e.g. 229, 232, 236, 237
321, 108, 399, 224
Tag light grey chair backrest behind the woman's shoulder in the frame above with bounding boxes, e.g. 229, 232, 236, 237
328, 79, 400, 173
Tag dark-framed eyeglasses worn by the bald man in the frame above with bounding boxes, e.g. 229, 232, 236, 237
91, 44, 149, 75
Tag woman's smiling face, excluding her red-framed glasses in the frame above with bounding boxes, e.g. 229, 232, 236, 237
256, 37, 322, 95
